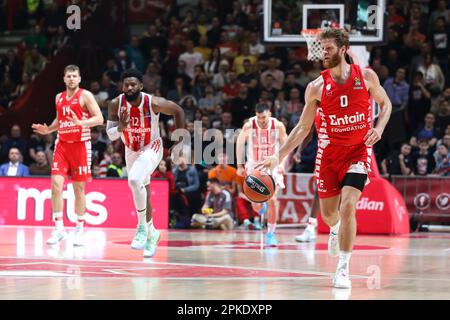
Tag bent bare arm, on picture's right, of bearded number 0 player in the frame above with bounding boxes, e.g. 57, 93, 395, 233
363, 69, 392, 146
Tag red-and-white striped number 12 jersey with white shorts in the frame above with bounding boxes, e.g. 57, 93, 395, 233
118, 92, 163, 185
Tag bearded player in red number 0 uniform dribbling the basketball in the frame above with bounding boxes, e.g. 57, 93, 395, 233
257, 29, 392, 288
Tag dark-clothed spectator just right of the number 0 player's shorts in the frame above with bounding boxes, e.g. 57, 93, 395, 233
381, 142, 413, 176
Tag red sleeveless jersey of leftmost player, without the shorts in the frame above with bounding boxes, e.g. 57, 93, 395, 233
56, 88, 91, 142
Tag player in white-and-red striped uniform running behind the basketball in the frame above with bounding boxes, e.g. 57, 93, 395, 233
236, 103, 287, 246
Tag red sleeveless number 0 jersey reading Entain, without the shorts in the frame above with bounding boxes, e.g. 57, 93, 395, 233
318, 64, 372, 146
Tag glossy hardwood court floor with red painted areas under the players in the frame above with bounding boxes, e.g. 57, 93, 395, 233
0, 226, 450, 300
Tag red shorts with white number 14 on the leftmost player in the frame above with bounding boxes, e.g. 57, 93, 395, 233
52, 141, 92, 181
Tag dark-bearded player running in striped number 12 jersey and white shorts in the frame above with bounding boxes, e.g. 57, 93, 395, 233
107, 69, 185, 257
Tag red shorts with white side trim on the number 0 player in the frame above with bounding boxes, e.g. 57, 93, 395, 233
314, 142, 372, 199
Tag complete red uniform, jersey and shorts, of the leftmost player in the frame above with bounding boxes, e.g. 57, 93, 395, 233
52, 88, 92, 181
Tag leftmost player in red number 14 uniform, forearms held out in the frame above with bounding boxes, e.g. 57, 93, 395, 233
32, 65, 103, 246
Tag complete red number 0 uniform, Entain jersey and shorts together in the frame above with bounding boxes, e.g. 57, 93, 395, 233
314, 64, 372, 198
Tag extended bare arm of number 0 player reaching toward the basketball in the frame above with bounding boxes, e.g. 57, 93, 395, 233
256, 81, 318, 169
